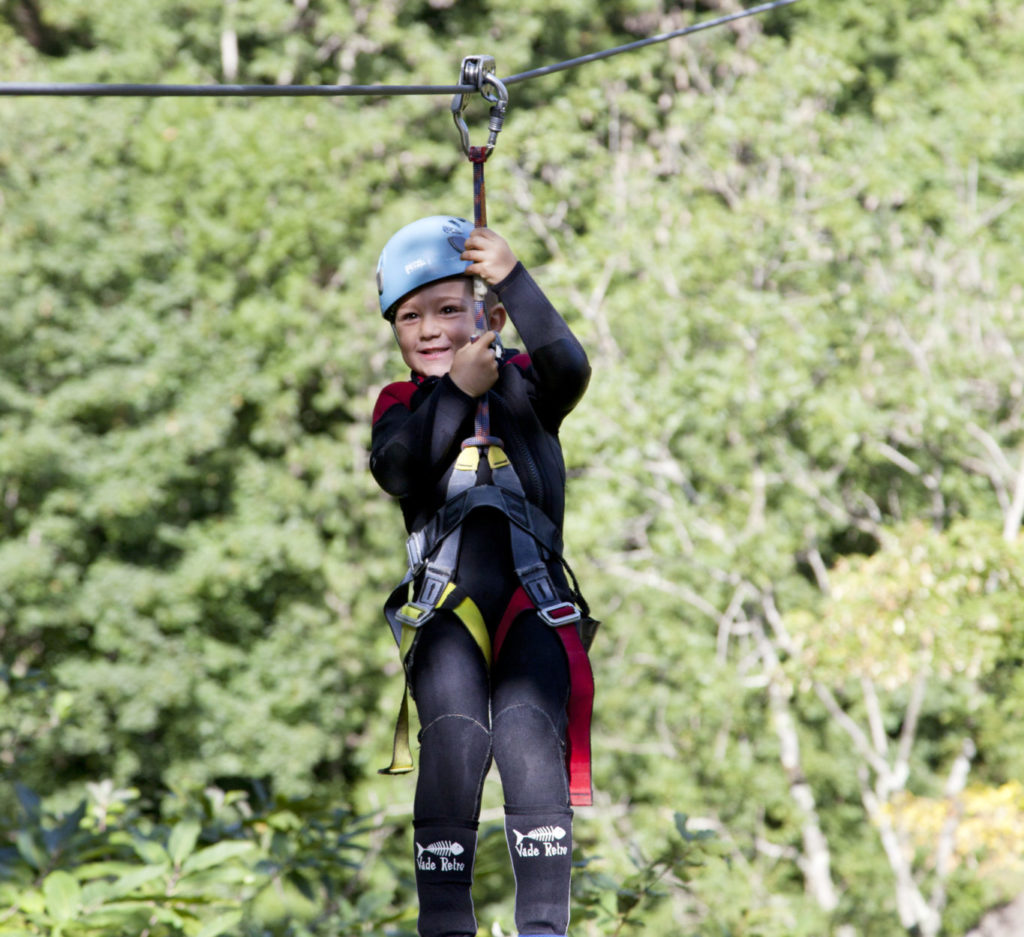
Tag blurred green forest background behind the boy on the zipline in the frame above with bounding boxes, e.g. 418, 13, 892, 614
0, 0, 1024, 937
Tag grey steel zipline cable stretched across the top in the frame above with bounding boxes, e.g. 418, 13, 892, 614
0, 0, 799, 97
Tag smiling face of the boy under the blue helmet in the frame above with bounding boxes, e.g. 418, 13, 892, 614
394, 278, 476, 377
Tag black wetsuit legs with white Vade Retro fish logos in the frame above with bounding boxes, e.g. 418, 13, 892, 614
410, 531, 572, 937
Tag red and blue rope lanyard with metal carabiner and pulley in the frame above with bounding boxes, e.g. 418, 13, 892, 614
452, 55, 509, 449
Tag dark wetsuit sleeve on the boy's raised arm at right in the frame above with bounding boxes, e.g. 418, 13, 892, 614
494, 263, 590, 418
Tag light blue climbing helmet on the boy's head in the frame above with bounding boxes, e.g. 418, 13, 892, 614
377, 215, 473, 321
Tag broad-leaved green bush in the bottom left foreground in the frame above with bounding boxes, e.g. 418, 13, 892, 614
0, 783, 381, 937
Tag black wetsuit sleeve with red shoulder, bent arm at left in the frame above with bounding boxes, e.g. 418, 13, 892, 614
370, 375, 476, 498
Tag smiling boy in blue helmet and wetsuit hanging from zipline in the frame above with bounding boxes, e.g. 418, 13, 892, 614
370, 215, 593, 937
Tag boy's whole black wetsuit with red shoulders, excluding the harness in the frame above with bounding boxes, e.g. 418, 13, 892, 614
371, 264, 590, 937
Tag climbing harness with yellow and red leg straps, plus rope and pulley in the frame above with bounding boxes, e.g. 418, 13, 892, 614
382, 55, 594, 805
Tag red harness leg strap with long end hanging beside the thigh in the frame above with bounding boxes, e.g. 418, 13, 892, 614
494, 586, 594, 807
